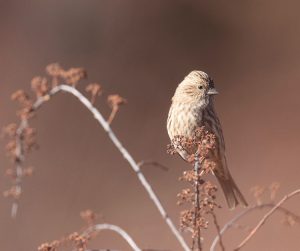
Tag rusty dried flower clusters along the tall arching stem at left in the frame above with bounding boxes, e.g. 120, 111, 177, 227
3, 63, 126, 216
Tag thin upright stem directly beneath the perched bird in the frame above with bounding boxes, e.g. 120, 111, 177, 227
192, 153, 202, 251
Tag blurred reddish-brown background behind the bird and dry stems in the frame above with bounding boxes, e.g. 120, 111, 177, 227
0, 0, 300, 251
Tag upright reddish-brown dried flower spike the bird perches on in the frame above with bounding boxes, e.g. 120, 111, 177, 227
167, 127, 220, 250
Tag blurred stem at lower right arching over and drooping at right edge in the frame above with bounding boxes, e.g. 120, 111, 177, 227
209, 203, 300, 251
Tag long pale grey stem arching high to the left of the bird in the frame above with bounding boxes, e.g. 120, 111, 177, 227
15, 85, 190, 251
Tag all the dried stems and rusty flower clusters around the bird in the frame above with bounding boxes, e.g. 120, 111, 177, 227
3, 63, 300, 251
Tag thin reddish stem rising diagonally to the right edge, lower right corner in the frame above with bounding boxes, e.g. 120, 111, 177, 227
234, 189, 300, 251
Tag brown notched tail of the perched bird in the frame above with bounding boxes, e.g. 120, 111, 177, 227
216, 173, 248, 209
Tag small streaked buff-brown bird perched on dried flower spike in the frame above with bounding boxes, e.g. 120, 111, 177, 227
167, 71, 248, 209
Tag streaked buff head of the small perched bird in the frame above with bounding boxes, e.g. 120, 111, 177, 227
173, 71, 218, 105
